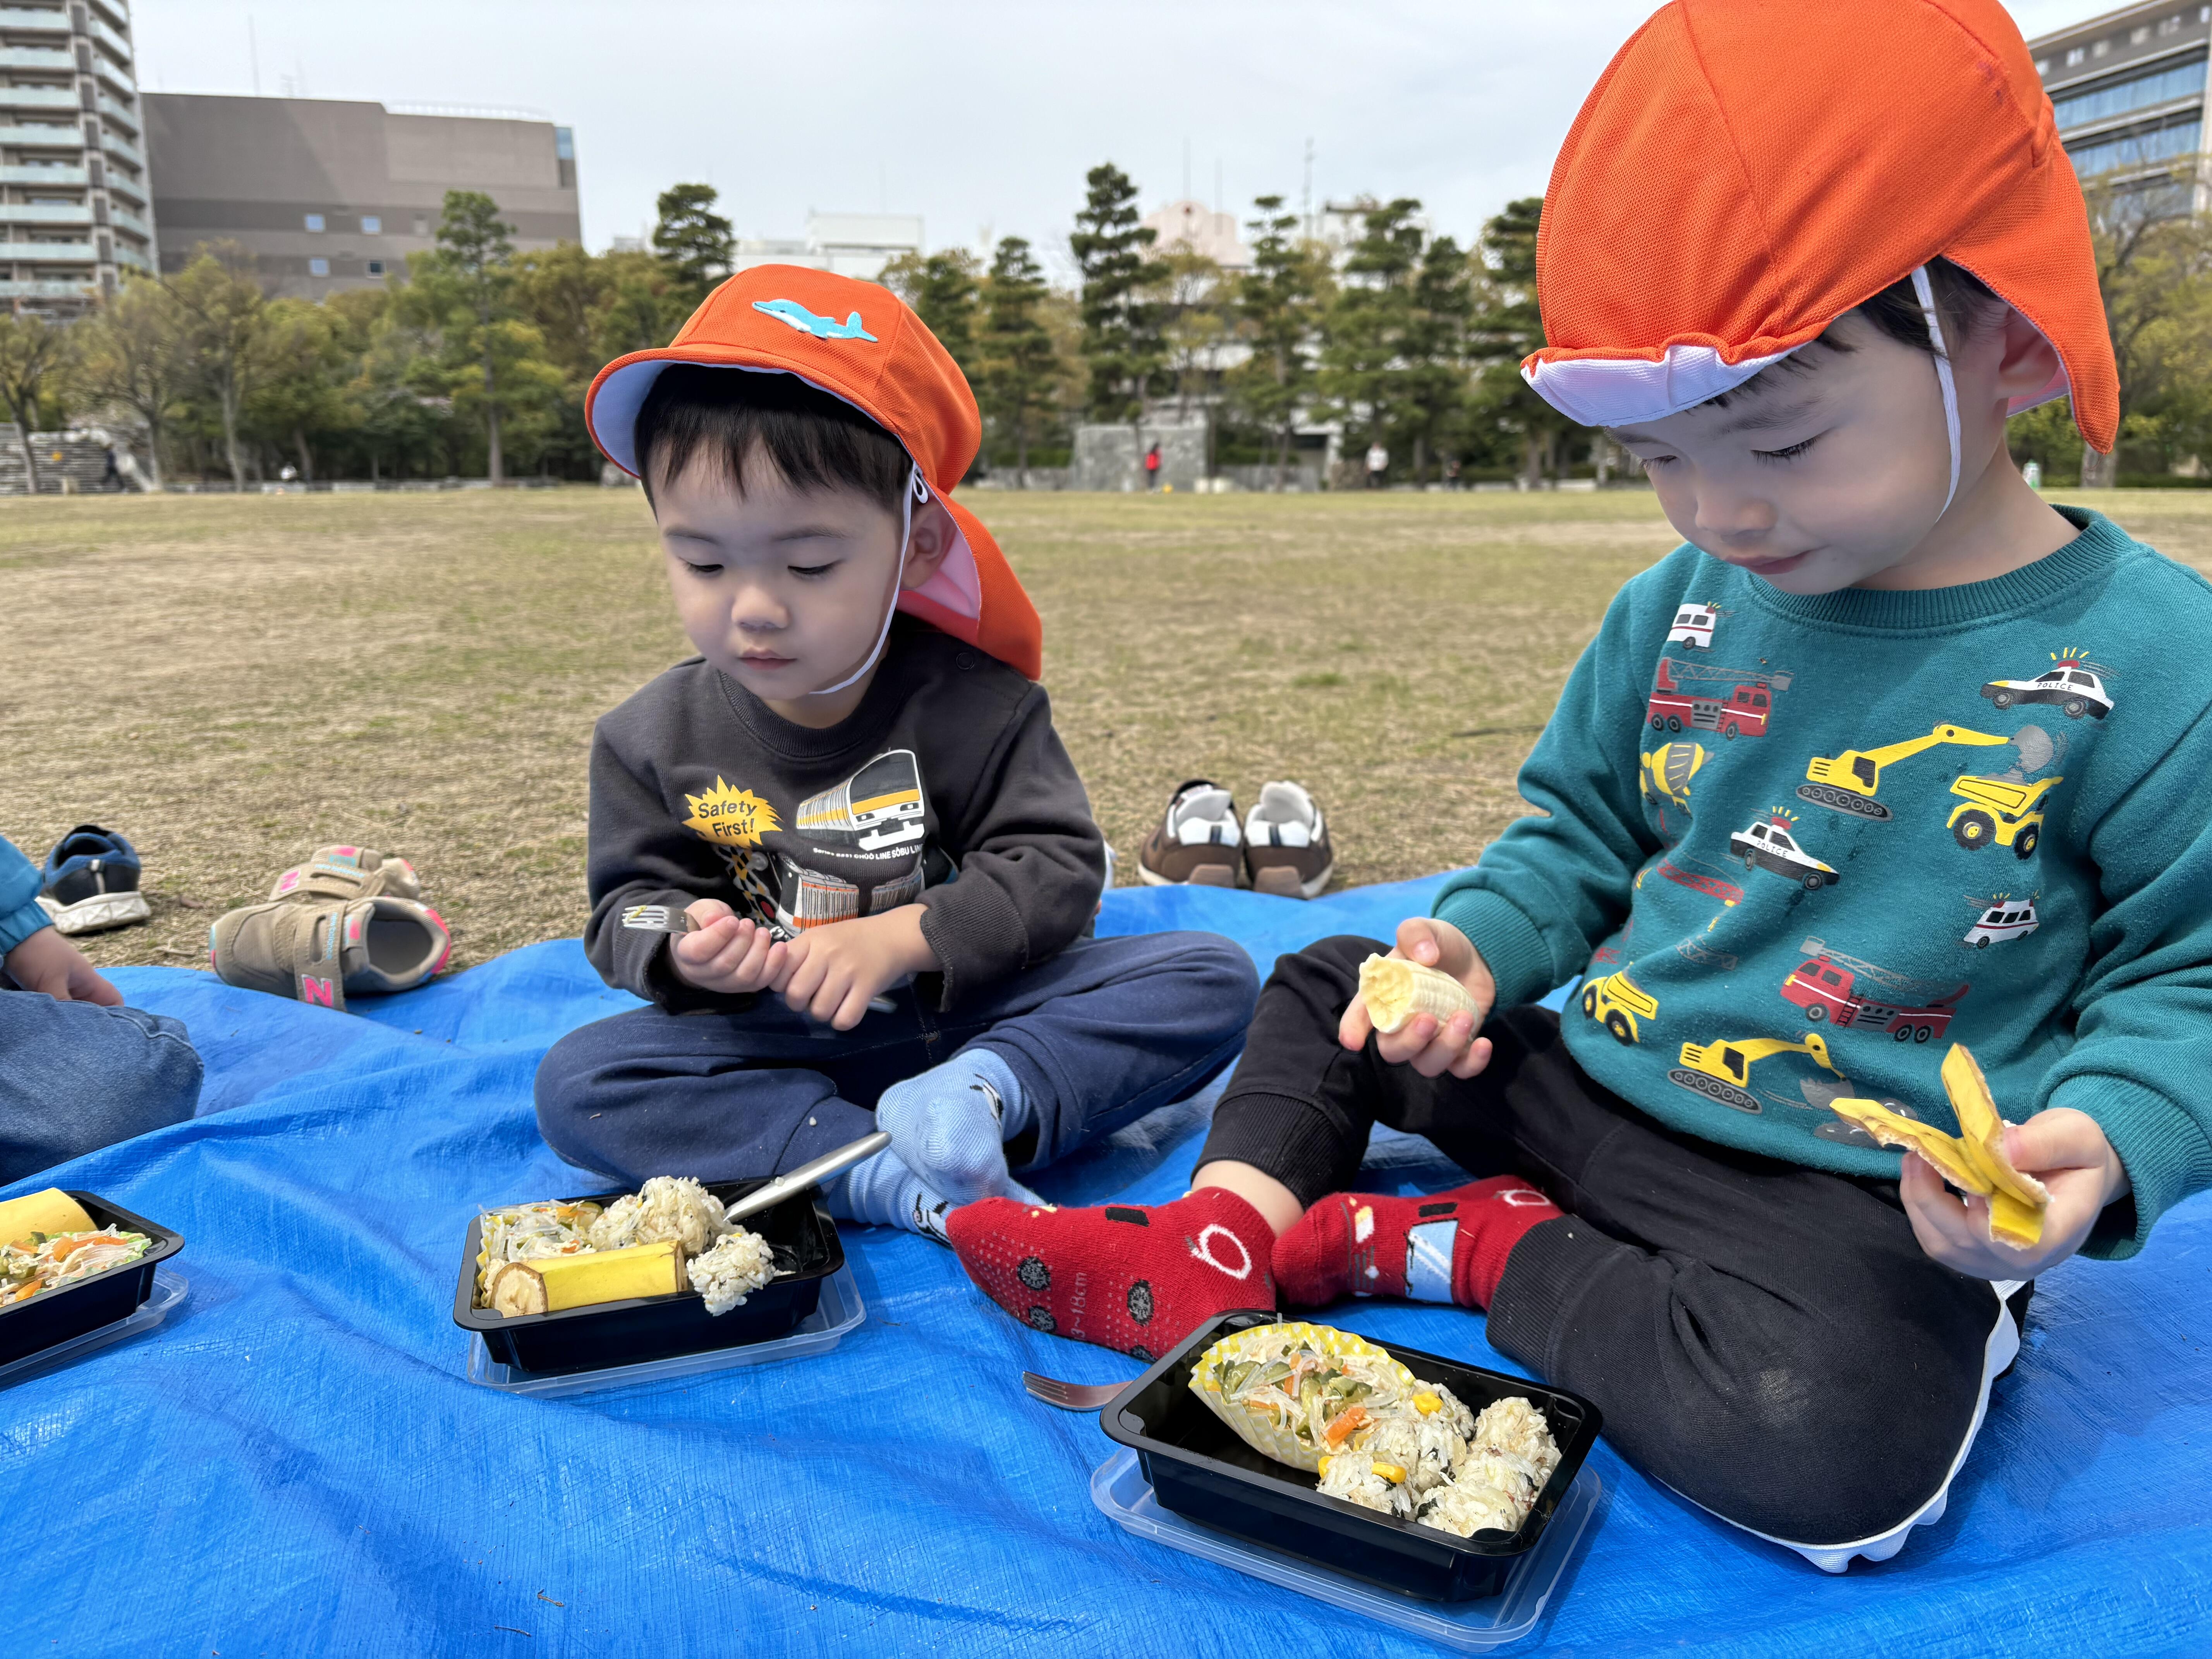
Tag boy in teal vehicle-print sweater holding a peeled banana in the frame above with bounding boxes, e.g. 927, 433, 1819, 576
953, 0, 2212, 1571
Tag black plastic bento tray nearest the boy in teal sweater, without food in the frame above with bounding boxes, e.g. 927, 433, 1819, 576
1099, 1312, 1604, 1601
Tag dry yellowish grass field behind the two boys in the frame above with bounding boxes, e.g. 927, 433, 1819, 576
17, 489, 2212, 964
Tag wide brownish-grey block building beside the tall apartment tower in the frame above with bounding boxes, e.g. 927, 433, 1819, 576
143, 94, 584, 299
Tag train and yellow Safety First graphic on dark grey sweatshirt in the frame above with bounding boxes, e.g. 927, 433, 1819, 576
686, 750, 929, 938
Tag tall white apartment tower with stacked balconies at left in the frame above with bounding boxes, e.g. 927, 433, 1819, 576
0, 0, 155, 316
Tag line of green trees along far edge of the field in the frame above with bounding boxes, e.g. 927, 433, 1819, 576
13, 164, 2176, 487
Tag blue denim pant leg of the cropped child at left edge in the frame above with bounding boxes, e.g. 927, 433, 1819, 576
0, 973, 199, 1186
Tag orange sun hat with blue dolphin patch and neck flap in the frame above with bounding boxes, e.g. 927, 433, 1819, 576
584, 265, 1044, 679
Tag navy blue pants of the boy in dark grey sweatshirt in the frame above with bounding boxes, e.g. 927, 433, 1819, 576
538, 933, 1259, 1183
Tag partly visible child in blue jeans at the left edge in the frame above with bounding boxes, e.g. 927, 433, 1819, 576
0, 838, 199, 1186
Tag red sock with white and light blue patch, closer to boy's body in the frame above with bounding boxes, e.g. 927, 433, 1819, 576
1274, 1175, 1559, 1307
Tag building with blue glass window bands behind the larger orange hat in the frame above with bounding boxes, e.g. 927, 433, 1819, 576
2028, 0, 2212, 212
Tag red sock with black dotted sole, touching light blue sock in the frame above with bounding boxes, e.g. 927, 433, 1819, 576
945, 1188, 1274, 1360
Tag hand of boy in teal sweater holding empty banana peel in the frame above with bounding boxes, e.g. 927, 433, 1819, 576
1898, 1106, 2130, 1279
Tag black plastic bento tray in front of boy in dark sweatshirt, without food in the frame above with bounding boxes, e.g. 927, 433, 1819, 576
453, 1181, 845, 1376
